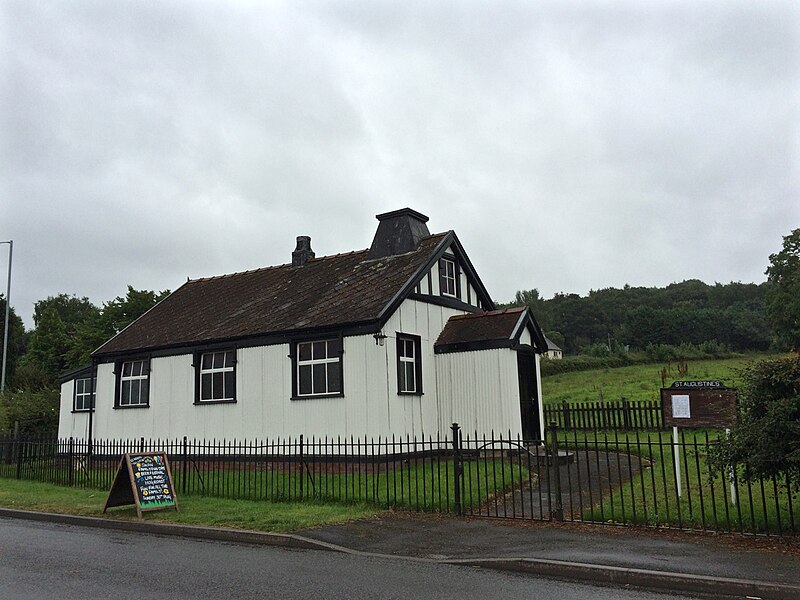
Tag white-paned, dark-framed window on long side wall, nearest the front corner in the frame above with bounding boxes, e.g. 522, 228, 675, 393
293, 339, 342, 397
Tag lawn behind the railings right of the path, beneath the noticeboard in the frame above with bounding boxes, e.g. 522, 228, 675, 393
562, 431, 800, 534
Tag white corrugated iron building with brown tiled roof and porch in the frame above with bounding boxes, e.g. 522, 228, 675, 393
59, 209, 547, 440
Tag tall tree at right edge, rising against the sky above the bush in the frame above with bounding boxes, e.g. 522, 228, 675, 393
767, 229, 800, 351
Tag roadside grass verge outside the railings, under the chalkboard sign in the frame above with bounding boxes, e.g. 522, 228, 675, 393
0, 478, 381, 532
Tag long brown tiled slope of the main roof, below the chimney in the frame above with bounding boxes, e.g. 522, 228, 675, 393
94, 232, 451, 357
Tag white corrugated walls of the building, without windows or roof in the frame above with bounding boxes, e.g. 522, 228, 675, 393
59, 298, 519, 440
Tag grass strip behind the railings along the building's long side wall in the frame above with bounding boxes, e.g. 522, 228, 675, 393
0, 457, 529, 526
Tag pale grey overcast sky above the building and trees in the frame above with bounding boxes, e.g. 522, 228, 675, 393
0, 0, 800, 327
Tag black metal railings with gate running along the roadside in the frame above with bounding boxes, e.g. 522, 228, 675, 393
0, 424, 800, 535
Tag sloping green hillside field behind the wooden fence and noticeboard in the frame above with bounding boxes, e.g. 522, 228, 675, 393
542, 354, 779, 404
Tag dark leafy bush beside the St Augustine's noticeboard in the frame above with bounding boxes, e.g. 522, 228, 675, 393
711, 356, 800, 488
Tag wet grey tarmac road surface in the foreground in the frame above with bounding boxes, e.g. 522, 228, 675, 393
0, 518, 685, 600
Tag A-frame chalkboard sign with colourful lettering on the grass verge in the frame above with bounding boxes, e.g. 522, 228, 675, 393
103, 452, 178, 519
